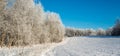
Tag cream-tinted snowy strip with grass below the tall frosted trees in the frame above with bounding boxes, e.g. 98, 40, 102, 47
0, 44, 56, 56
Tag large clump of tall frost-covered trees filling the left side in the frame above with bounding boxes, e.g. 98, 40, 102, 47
0, 0, 64, 46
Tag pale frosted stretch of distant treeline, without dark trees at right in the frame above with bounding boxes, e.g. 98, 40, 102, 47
65, 28, 106, 37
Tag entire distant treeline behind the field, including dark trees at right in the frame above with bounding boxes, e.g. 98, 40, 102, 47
65, 19, 120, 37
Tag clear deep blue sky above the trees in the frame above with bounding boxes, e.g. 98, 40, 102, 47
34, 0, 120, 29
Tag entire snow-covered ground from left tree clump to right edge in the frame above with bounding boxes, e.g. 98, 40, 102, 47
0, 37, 120, 56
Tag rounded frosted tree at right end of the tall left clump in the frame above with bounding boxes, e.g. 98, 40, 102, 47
46, 12, 65, 42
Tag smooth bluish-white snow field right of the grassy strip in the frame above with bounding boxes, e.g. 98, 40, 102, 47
45, 37, 120, 56
